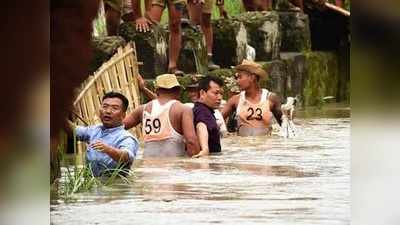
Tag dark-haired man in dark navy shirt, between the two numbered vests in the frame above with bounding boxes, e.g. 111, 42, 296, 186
193, 76, 224, 158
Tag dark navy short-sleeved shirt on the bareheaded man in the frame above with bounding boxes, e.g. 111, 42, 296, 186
193, 102, 221, 152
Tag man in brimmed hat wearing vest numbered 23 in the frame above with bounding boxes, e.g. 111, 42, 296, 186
222, 60, 282, 136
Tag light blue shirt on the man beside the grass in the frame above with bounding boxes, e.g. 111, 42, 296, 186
75, 125, 139, 176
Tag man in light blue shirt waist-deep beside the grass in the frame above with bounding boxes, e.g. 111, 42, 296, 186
75, 92, 139, 176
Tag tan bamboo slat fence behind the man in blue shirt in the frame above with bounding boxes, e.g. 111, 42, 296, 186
73, 42, 142, 152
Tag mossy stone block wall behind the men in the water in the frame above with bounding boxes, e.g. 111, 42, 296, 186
90, 11, 350, 106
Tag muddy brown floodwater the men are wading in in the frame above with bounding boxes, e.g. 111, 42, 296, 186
50, 105, 350, 225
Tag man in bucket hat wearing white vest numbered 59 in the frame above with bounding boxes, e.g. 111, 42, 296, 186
124, 74, 200, 158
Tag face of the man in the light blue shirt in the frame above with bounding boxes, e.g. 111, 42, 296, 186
100, 98, 125, 128
